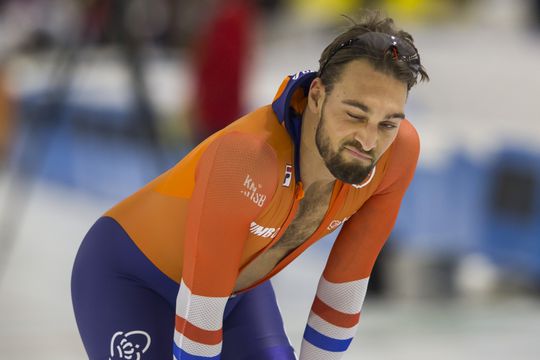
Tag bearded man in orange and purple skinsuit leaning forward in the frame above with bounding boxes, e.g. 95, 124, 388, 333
72, 14, 427, 360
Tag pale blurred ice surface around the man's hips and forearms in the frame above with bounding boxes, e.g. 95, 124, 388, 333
0, 184, 540, 360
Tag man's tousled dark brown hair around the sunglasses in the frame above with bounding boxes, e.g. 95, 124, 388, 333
318, 11, 429, 92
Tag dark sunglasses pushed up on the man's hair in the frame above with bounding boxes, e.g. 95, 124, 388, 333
319, 32, 421, 77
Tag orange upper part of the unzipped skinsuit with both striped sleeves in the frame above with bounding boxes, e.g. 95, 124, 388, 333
106, 72, 419, 360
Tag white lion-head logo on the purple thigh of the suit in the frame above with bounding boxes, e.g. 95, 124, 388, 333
109, 330, 152, 360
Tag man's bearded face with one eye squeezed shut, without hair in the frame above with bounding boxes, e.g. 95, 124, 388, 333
315, 60, 407, 184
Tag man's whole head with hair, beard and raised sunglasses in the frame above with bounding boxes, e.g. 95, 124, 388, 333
308, 13, 428, 184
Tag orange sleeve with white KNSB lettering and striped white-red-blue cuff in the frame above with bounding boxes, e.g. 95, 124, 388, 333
174, 133, 277, 360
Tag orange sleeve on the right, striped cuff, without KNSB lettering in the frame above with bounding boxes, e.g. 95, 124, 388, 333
300, 125, 419, 360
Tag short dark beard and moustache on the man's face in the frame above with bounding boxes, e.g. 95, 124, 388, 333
315, 104, 375, 184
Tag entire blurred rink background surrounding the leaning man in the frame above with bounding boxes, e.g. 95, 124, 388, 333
0, 0, 540, 360
